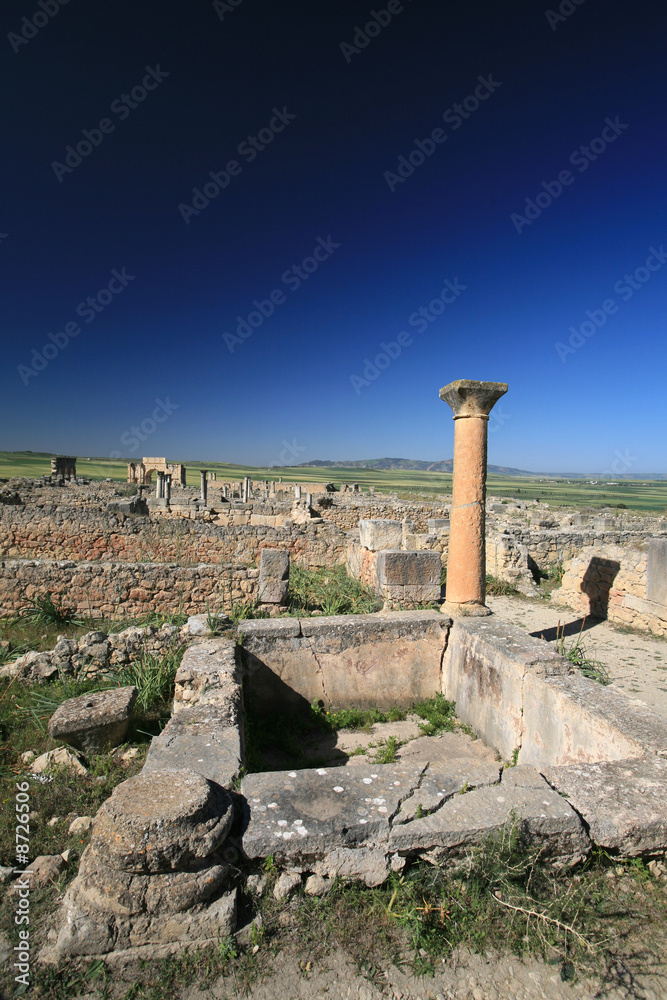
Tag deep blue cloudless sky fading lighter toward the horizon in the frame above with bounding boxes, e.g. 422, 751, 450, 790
0, 0, 667, 474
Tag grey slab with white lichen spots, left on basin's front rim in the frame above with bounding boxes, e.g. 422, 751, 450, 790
241, 764, 424, 860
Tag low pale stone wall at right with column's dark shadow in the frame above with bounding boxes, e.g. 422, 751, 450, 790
552, 540, 667, 636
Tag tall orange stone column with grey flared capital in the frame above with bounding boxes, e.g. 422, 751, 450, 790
440, 379, 507, 614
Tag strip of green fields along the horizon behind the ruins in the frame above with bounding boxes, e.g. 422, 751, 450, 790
0, 451, 667, 513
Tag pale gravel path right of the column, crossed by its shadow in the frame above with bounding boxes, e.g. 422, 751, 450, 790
487, 596, 667, 718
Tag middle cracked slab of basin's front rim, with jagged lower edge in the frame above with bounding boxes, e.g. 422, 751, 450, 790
389, 768, 590, 862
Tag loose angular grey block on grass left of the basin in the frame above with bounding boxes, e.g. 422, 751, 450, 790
49, 687, 137, 754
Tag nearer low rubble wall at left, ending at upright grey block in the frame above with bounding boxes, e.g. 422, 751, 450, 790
0, 559, 259, 617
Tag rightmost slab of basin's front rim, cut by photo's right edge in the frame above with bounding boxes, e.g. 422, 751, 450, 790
544, 754, 667, 856
